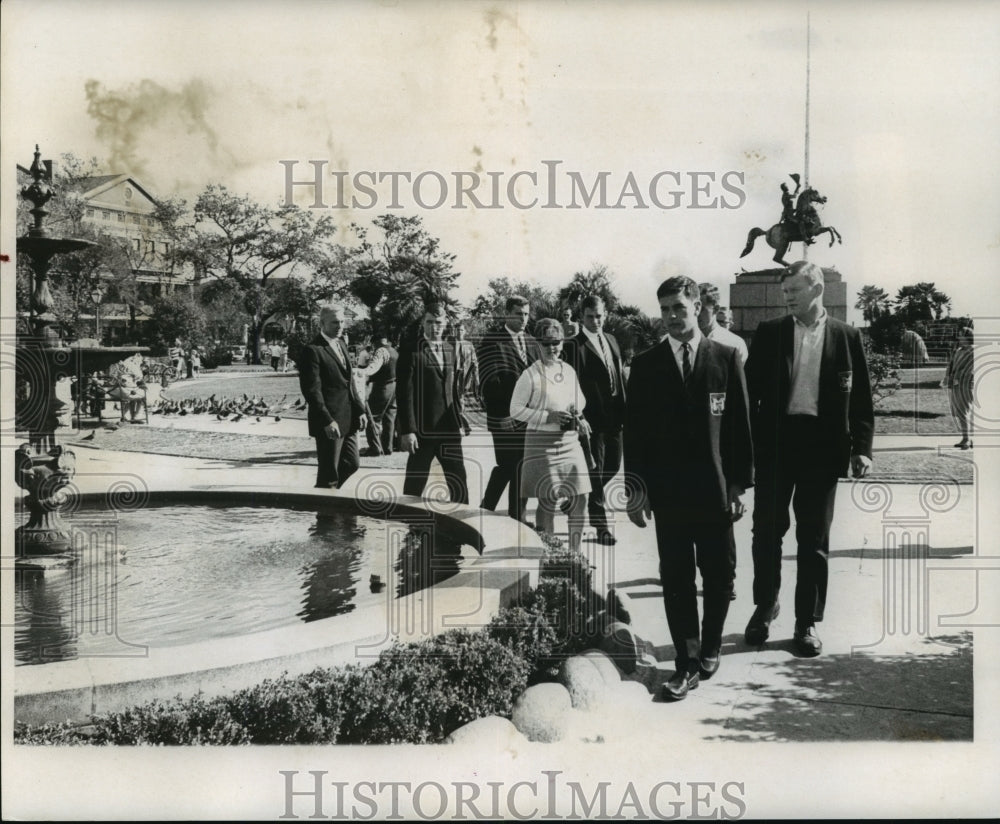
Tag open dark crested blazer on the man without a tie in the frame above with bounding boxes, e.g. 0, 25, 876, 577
747, 315, 875, 478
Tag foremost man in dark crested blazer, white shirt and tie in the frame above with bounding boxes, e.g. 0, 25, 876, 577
624, 277, 753, 701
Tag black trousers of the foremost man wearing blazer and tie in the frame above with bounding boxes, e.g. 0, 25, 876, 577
653, 507, 735, 672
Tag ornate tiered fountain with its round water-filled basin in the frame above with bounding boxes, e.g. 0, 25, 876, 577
14, 148, 545, 724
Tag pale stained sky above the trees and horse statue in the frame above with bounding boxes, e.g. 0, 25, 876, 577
0, 0, 1000, 326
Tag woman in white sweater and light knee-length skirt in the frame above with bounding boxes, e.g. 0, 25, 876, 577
510, 318, 590, 549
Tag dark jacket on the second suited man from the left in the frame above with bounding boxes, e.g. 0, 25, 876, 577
396, 337, 461, 438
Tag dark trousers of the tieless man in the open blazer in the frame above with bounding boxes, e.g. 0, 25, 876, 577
753, 415, 837, 624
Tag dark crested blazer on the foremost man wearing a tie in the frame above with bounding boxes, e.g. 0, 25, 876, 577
624, 337, 753, 518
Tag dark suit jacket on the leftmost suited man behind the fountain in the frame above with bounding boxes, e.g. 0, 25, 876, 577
298, 335, 365, 437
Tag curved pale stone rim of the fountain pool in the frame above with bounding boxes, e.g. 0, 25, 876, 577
14, 486, 544, 724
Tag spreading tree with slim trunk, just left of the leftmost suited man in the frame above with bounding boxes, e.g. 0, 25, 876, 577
177, 184, 336, 363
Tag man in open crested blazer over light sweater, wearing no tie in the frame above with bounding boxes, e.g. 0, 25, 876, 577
746, 261, 874, 655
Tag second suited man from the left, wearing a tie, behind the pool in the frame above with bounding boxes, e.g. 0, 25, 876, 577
396, 303, 469, 504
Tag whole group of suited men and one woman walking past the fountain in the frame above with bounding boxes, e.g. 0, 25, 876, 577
299, 262, 874, 700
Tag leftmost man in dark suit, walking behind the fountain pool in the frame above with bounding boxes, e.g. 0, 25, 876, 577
299, 306, 365, 488
